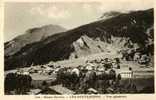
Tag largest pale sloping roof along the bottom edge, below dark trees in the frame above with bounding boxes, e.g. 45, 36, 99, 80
49, 85, 75, 94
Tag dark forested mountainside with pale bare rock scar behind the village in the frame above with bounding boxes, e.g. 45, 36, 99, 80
5, 9, 154, 70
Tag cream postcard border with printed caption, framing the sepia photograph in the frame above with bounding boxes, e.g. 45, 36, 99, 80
0, 0, 156, 100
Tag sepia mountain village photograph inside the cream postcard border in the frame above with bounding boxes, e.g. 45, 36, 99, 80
3, 0, 155, 95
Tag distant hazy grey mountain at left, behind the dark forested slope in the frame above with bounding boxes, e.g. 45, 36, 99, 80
5, 25, 65, 56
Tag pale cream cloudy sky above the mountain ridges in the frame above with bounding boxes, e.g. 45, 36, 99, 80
4, 0, 153, 42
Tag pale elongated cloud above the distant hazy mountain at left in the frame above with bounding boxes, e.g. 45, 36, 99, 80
30, 5, 71, 19
